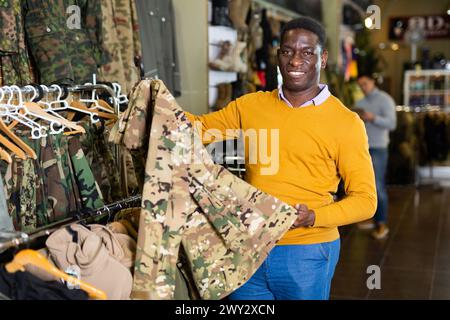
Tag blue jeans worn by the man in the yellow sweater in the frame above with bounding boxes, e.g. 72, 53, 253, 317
229, 239, 341, 300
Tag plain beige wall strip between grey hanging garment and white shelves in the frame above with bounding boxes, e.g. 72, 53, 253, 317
173, 0, 208, 114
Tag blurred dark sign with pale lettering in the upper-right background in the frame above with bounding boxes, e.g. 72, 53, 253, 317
389, 15, 450, 40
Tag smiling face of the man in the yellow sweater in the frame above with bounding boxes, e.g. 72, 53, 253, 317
278, 29, 328, 92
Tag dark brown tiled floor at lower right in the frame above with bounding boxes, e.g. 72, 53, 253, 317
331, 187, 450, 299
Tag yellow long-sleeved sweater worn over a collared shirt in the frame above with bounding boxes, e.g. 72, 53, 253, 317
187, 90, 377, 245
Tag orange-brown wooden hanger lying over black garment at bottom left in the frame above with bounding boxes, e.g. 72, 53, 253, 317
5, 249, 107, 300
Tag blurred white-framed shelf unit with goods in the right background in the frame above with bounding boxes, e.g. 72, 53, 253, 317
403, 70, 450, 110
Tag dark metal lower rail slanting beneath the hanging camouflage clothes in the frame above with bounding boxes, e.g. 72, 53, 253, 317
0, 195, 141, 253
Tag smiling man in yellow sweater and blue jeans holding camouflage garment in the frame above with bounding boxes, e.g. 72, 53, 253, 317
188, 17, 377, 300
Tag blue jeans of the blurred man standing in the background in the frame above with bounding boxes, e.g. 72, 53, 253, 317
369, 148, 388, 223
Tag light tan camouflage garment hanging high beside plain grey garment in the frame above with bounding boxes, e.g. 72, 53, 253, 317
99, 0, 142, 93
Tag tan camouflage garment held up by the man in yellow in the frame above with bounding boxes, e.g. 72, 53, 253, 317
109, 81, 296, 299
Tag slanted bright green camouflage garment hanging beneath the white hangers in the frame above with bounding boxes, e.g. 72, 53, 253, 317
68, 136, 105, 209
